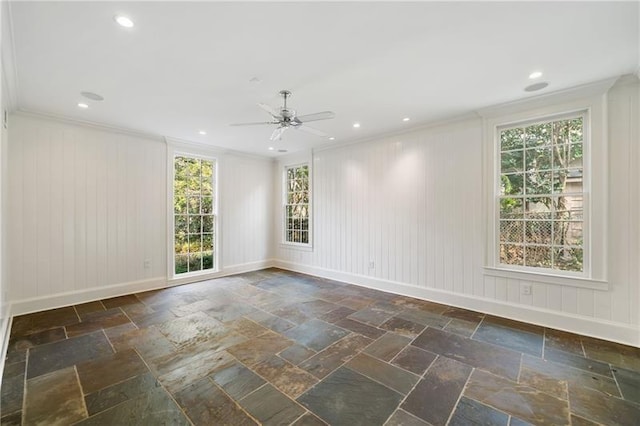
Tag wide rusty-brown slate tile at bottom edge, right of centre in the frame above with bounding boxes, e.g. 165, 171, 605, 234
464, 369, 573, 425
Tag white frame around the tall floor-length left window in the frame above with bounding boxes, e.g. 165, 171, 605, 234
167, 149, 221, 281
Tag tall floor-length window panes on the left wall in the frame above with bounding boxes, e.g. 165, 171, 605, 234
173, 155, 217, 275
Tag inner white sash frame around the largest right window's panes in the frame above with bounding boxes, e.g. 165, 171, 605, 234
493, 109, 591, 278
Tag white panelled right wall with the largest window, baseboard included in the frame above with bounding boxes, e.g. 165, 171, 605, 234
276, 80, 640, 346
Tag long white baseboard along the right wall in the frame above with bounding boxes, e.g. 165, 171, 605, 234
274, 260, 640, 347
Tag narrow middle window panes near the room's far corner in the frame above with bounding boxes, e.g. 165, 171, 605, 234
284, 164, 311, 245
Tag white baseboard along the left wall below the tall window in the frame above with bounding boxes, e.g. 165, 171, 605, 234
11, 260, 274, 315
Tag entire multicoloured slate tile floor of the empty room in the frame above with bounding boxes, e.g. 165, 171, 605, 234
0, 269, 640, 426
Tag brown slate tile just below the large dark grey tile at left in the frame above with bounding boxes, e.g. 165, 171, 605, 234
76, 349, 148, 395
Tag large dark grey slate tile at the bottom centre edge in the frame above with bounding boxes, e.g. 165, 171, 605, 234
298, 367, 402, 425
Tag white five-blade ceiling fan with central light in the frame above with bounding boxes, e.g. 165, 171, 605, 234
231, 90, 335, 141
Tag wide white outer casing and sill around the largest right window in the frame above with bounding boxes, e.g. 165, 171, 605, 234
476, 78, 616, 291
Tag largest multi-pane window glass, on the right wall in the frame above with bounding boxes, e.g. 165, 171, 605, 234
497, 114, 586, 273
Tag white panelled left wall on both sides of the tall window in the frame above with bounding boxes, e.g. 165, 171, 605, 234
7, 114, 273, 315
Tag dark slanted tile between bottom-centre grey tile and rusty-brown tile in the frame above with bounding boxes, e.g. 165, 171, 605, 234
401, 357, 472, 425
